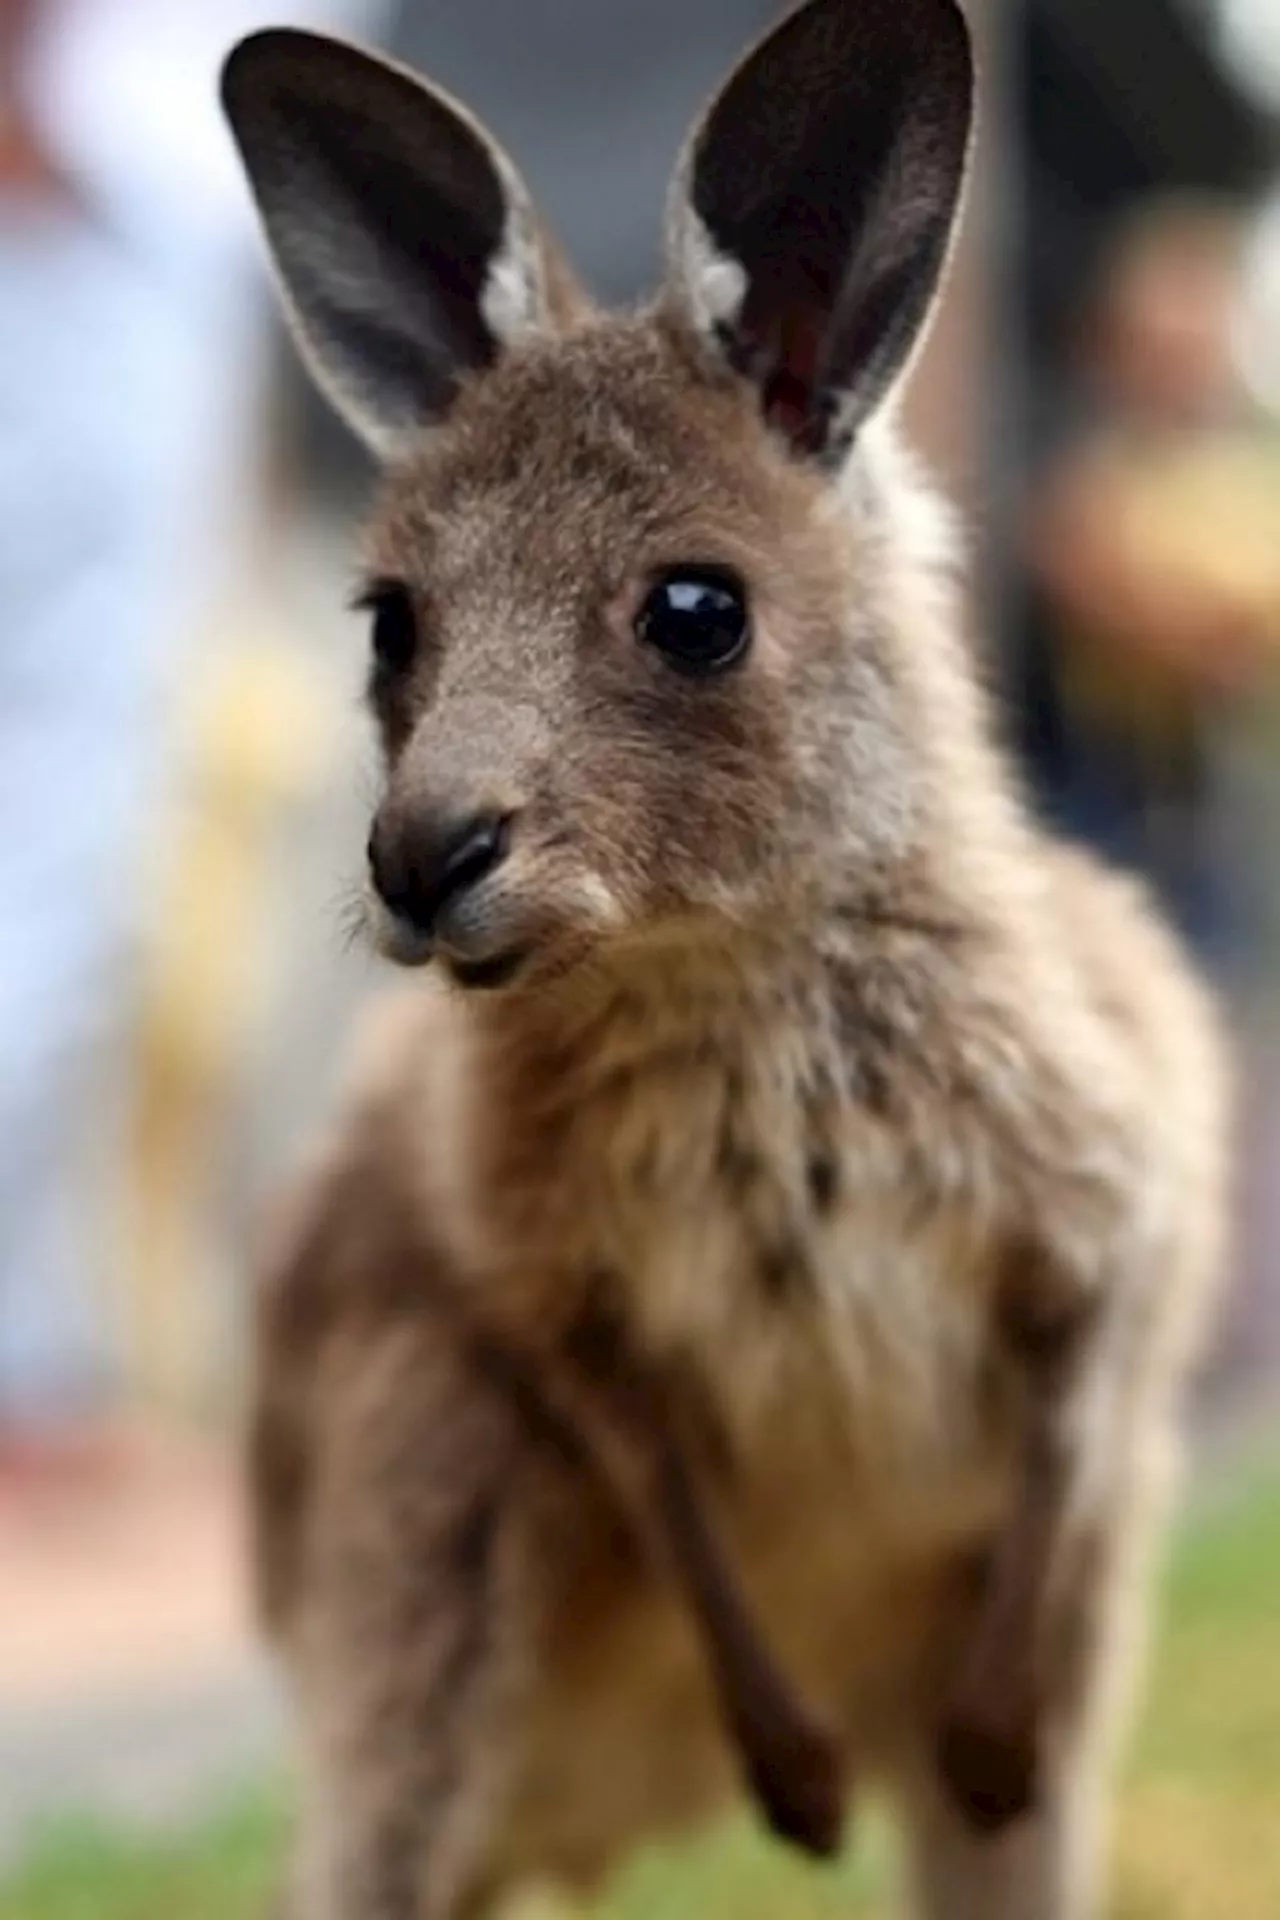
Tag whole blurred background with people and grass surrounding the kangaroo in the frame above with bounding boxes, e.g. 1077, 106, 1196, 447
0, 0, 1280, 1920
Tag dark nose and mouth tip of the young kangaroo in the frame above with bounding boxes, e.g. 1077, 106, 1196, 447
368, 804, 514, 968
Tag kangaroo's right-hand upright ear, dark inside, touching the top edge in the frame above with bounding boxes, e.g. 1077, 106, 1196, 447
668, 0, 973, 463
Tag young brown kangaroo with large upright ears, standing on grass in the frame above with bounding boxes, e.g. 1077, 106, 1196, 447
225, 0, 1228, 1920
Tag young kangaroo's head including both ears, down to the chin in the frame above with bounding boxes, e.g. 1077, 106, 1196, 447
223, 0, 973, 983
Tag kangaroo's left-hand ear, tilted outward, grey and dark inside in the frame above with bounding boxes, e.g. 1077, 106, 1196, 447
223, 29, 574, 455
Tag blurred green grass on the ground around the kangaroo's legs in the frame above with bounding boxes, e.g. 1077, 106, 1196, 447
0, 1473, 1280, 1920
